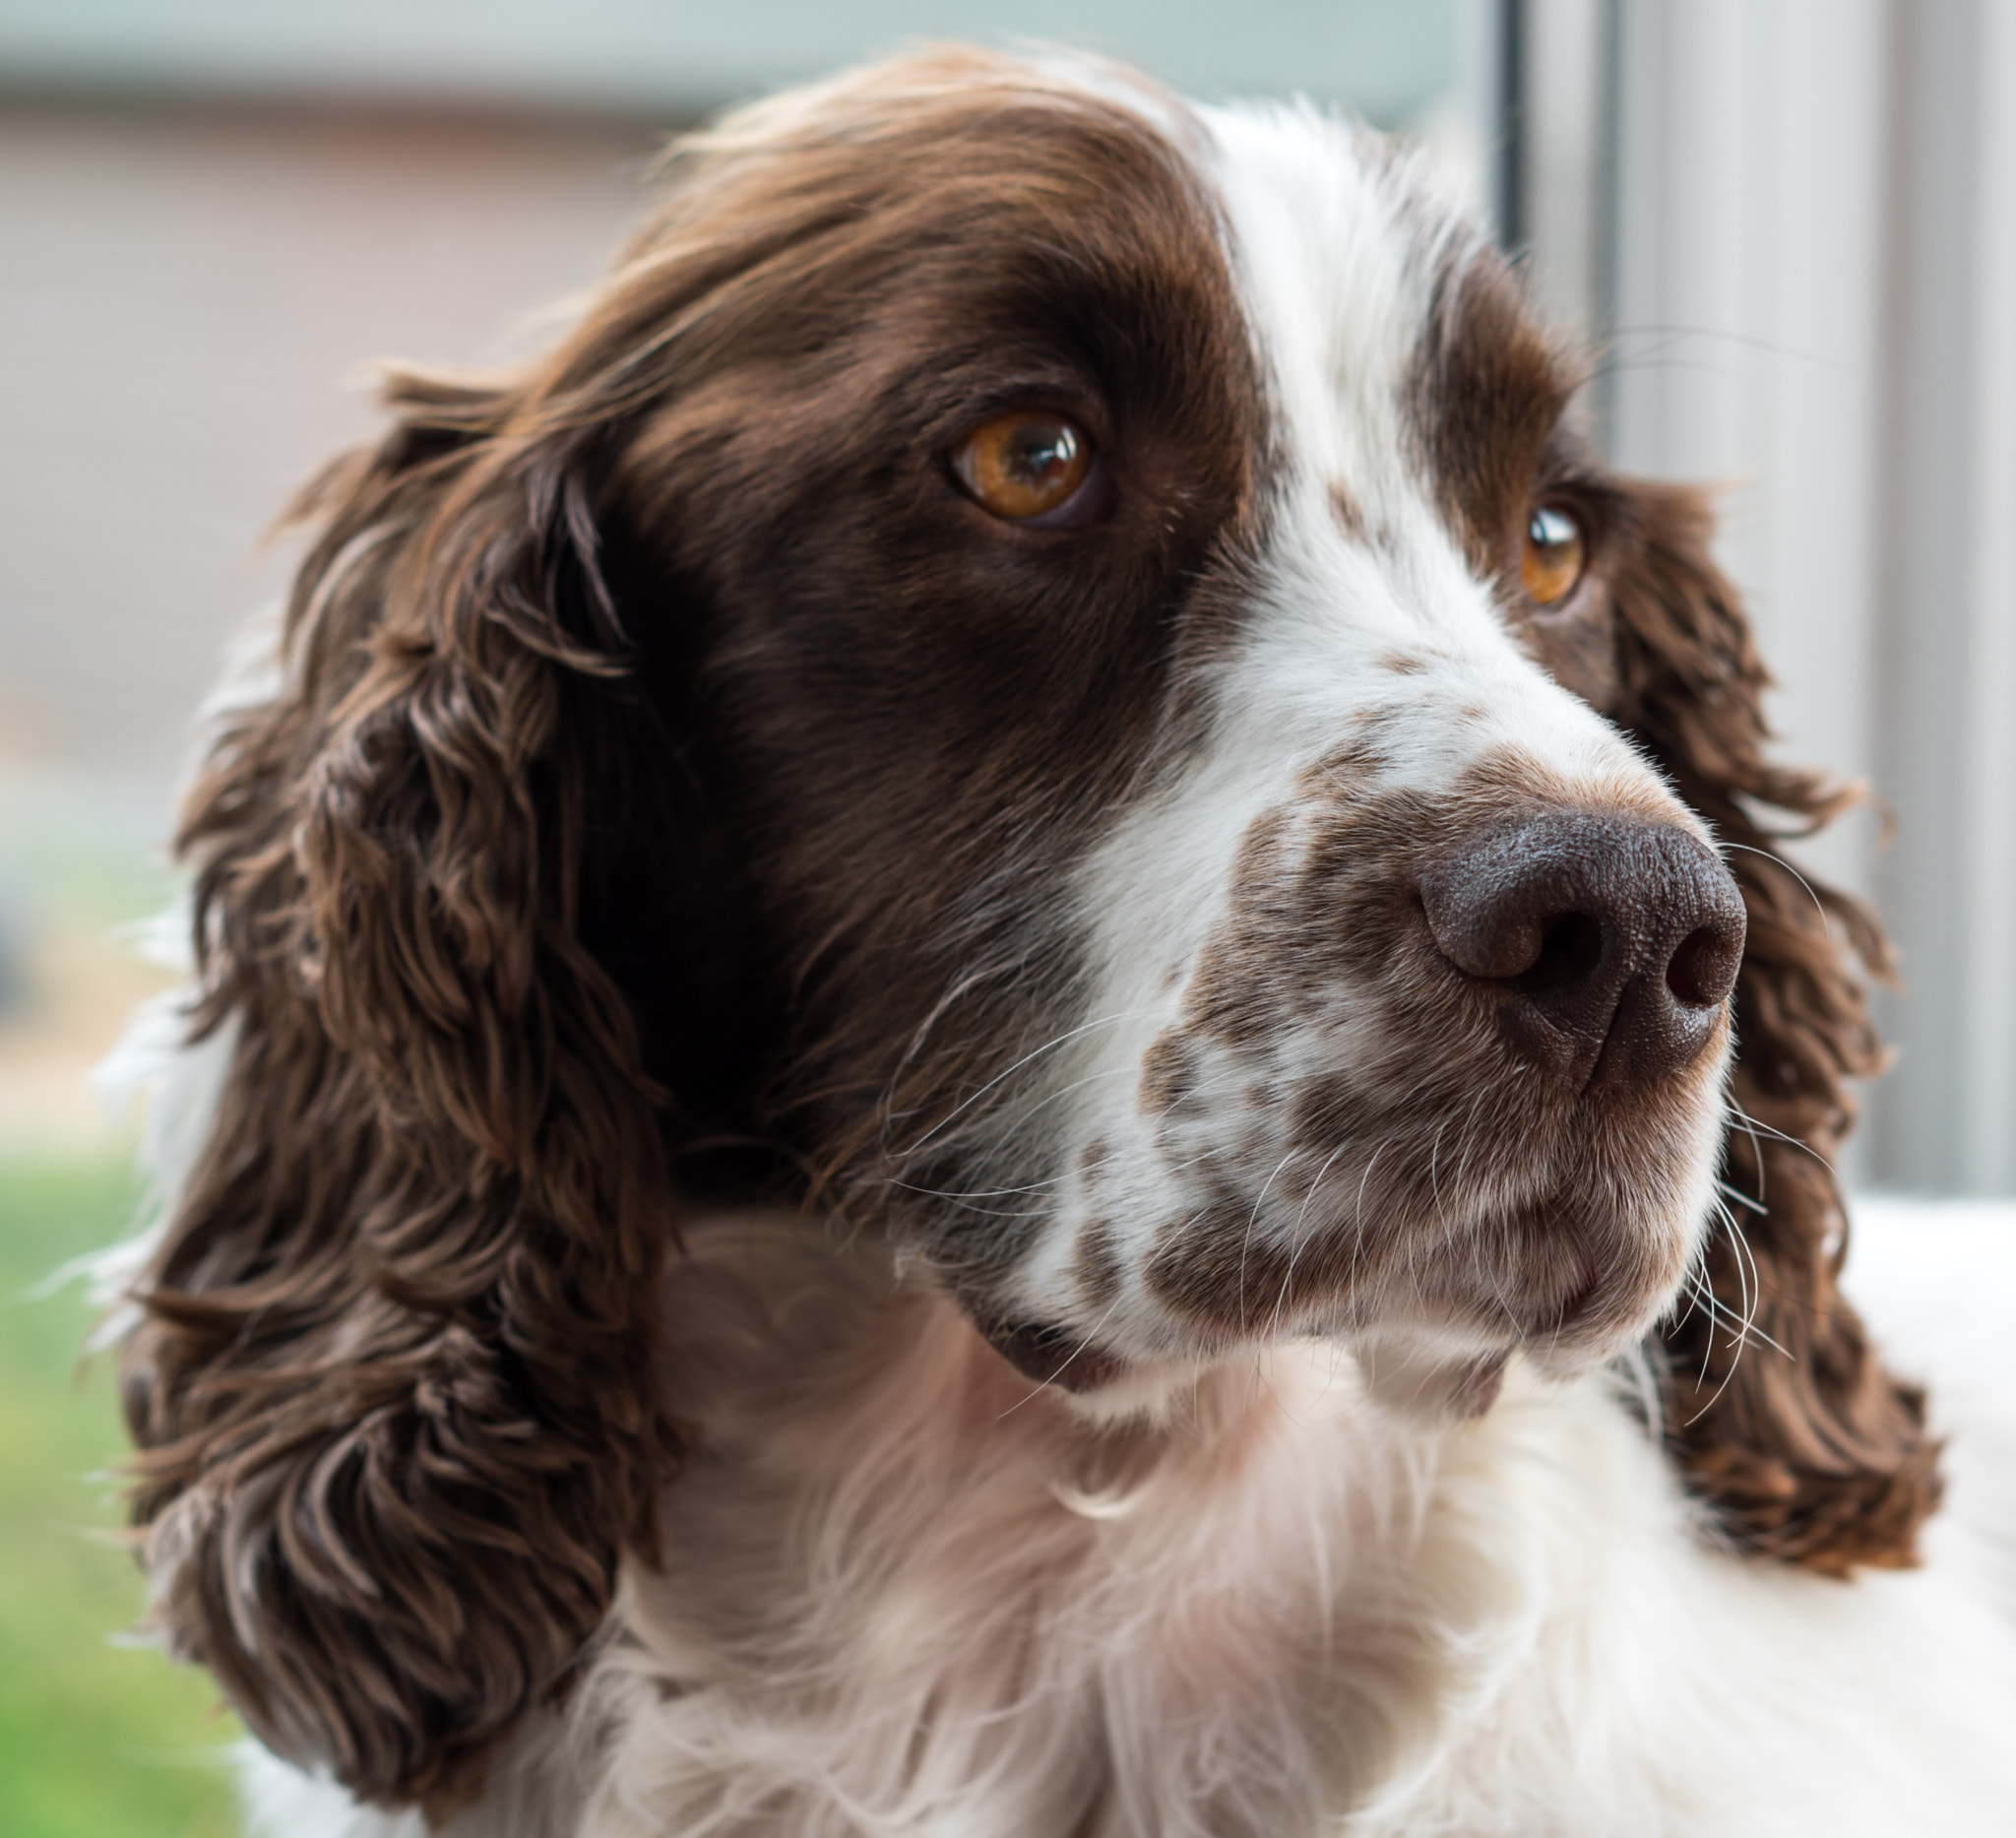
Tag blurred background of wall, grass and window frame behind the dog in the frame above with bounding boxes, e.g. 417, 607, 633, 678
0, 0, 2016, 1838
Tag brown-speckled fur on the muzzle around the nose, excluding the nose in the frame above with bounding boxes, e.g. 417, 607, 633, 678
1145, 750, 1720, 1336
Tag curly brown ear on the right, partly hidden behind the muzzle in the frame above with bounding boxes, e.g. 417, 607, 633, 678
1610, 483, 1939, 1576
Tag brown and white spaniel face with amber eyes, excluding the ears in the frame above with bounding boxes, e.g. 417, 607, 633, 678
604, 64, 1744, 1388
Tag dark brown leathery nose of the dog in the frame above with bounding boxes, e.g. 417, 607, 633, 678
1419, 812, 1744, 1080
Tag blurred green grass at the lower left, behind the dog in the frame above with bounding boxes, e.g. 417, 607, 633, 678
0, 1153, 238, 1838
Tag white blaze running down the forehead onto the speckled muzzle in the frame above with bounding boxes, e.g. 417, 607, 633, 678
999, 106, 1722, 1386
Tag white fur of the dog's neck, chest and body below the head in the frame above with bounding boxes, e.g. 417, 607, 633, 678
239, 1209, 2016, 1838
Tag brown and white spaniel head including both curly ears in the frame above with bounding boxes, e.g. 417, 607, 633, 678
129, 52, 1931, 1800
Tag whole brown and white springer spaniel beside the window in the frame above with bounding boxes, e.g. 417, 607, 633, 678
106, 50, 2016, 1838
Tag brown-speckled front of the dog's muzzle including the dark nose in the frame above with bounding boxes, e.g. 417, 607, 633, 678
1141, 758, 1717, 1344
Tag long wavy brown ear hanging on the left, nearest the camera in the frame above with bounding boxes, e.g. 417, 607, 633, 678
125, 362, 669, 1809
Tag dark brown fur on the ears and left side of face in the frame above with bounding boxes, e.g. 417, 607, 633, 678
125, 54, 1933, 1809
